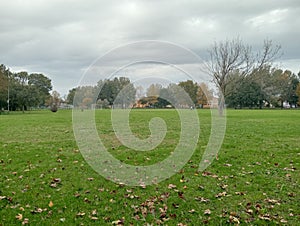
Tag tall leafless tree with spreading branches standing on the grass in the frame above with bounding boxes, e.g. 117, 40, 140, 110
205, 38, 281, 115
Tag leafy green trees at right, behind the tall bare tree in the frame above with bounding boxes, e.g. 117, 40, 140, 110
224, 66, 300, 108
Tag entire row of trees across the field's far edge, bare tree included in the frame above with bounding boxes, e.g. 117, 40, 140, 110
0, 38, 300, 115
